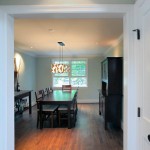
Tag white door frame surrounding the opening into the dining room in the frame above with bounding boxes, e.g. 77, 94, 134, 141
0, 4, 137, 150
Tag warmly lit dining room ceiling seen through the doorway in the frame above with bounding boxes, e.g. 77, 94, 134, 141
15, 18, 123, 57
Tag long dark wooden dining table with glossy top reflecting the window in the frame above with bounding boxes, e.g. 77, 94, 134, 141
37, 90, 77, 129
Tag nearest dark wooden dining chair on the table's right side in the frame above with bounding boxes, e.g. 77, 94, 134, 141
58, 94, 77, 126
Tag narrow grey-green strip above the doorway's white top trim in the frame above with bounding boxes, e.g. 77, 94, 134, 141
0, 0, 136, 5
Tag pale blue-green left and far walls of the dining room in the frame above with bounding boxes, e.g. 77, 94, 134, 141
14, 53, 101, 104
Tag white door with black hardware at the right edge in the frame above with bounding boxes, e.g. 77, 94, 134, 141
137, 0, 150, 150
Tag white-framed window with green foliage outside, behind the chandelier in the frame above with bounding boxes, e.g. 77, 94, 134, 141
52, 60, 87, 87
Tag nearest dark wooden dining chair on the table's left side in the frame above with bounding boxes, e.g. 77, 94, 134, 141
35, 90, 58, 128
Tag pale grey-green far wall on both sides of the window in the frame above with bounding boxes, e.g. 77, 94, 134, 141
36, 57, 101, 103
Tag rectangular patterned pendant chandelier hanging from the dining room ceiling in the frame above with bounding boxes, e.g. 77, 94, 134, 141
51, 42, 70, 73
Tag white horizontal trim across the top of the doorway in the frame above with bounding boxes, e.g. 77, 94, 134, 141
0, 4, 133, 16
